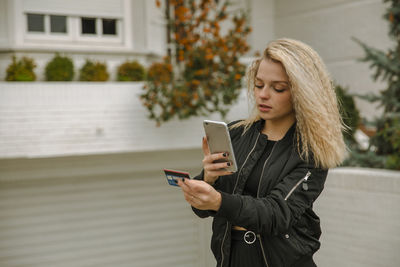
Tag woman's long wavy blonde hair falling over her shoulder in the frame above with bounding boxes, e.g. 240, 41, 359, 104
233, 38, 347, 168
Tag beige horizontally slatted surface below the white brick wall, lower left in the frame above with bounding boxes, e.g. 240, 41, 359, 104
0, 152, 204, 267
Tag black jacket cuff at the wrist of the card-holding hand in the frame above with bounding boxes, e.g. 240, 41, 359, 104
215, 191, 242, 221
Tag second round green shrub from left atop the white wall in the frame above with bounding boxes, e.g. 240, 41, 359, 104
45, 54, 74, 81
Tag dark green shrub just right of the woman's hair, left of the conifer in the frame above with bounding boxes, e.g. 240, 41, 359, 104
335, 85, 360, 143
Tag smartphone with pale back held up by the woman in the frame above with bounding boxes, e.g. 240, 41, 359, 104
203, 120, 237, 172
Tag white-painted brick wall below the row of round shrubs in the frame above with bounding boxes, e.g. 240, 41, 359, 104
0, 82, 248, 158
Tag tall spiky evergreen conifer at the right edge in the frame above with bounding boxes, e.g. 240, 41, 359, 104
355, 0, 400, 170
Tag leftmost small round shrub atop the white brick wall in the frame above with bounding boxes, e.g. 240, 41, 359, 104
6, 56, 36, 82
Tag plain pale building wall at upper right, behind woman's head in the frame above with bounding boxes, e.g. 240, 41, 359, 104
275, 0, 391, 118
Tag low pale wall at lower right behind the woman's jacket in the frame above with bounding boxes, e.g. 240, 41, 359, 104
315, 168, 400, 267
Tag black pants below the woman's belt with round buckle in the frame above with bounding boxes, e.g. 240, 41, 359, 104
229, 230, 317, 267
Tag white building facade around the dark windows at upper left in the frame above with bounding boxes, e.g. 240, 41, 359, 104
0, 0, 165, 81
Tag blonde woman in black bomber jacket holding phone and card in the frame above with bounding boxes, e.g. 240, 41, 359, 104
179, 39, 346, 267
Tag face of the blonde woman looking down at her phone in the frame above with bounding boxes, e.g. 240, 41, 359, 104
254, 59, 295, 124
